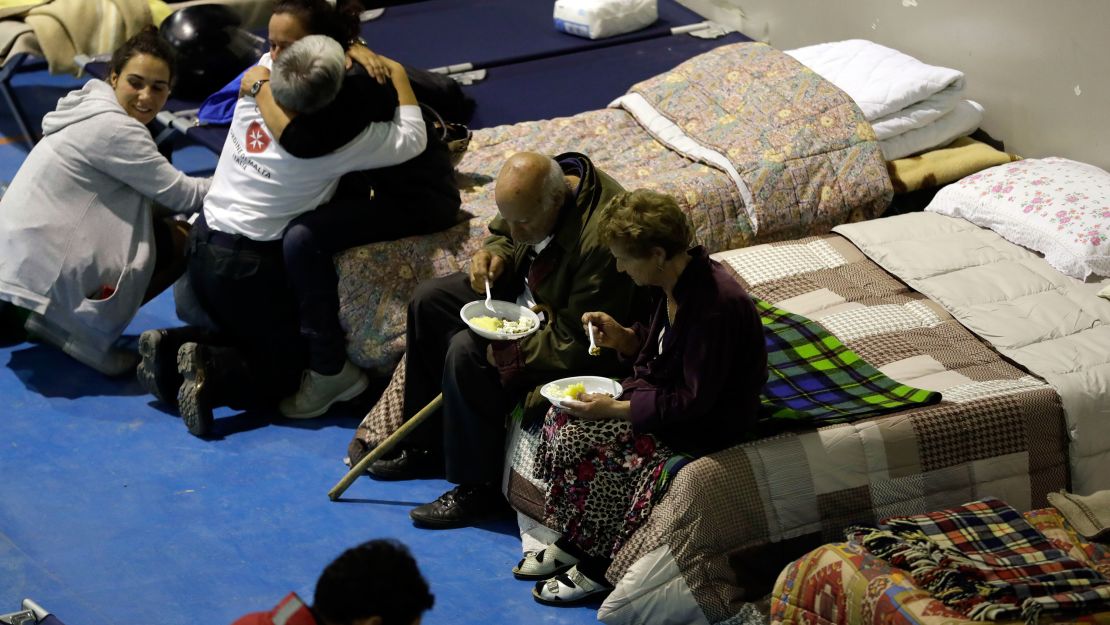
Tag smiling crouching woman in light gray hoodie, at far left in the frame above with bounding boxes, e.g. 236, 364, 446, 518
0, 28, 210, 375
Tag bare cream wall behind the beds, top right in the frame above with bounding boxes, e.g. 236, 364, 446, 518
680, 0, 1110, 170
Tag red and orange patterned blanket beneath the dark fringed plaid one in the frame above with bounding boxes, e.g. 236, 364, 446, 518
770, 507, 1110, 625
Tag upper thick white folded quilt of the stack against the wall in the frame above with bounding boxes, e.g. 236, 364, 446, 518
786, 39, 963, 122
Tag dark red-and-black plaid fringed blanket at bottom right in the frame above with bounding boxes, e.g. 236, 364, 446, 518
846, 497, 1110, 624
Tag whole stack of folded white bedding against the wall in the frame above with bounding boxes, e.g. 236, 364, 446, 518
787, 39, 982, 161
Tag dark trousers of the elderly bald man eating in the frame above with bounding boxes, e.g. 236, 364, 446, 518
404, 273, 524, 484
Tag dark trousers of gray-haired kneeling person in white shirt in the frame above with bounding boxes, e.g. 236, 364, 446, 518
189, 215, 307, 410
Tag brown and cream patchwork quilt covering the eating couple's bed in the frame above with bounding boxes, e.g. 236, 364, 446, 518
506, 213, 1110, 623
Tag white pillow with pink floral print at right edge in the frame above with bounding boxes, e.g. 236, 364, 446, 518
926, 157, 1110, 280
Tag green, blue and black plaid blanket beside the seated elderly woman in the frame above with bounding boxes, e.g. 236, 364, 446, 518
753, 298, 940, 424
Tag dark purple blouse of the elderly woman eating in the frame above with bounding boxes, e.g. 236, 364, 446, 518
620, 246, 767, 455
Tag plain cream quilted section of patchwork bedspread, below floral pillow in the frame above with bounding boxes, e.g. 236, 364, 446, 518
837, 212, 1110, 497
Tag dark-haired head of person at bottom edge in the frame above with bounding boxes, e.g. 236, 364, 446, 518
312, 540, 435, 625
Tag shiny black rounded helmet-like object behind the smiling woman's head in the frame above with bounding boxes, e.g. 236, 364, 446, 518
159, 4, 265, 100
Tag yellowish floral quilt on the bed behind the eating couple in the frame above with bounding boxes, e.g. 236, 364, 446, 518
335, 43, 892, 373
